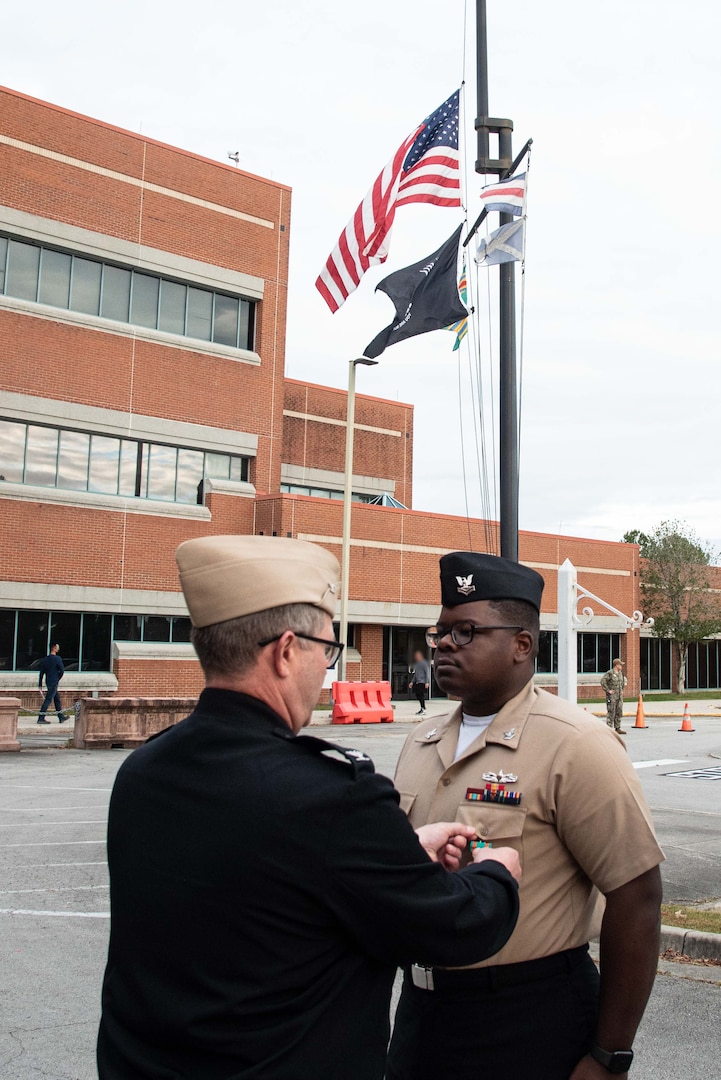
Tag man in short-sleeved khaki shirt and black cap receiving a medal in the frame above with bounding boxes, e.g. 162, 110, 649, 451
386, 552, 664, 1080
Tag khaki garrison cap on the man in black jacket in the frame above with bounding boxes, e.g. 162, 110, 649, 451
175, 536, 340, 626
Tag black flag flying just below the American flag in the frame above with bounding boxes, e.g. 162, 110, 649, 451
364, 225, 468, 360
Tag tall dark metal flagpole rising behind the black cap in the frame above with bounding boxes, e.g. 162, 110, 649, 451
476, 0, 518, 563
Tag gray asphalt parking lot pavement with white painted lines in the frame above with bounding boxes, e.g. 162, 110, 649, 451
0, 706, 721, 1080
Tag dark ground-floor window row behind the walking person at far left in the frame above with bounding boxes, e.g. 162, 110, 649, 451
0, 609, 190, 672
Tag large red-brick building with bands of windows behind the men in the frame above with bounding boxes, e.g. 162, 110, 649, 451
0, 90, 682, 701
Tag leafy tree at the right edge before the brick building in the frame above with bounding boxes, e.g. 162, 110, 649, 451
624, 521, 721, 693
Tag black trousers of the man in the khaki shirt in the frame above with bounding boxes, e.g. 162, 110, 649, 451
385, 946, 599, 1080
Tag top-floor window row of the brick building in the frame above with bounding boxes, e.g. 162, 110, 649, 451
0, 235, 255, 350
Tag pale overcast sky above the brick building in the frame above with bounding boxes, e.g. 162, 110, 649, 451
5, 0, 721, 548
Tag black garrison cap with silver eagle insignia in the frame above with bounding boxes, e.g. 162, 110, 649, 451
440, 551, 544, 611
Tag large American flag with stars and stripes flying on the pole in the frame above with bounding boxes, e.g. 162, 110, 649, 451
315, 90, 461, 311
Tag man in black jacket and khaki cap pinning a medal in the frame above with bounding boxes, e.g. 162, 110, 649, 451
98, 537, 520, 1080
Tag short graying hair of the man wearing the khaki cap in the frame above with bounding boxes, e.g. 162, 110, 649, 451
190, 604, 326, 676
